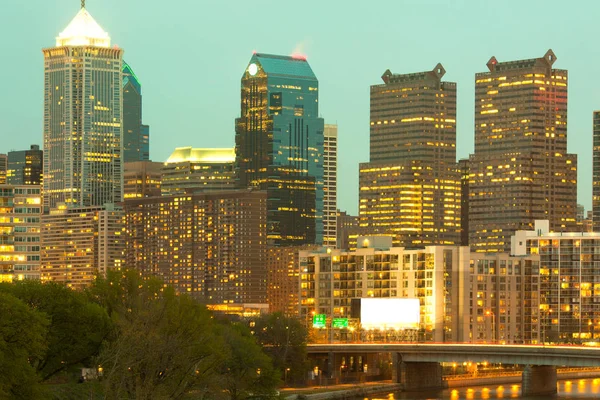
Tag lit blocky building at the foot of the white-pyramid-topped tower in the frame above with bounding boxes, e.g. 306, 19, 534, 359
40, 204, 125, 289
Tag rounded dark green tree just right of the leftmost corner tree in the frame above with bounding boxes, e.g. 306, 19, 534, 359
0, 280, 111, 381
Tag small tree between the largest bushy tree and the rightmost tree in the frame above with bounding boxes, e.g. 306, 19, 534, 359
220, 324, 281, 400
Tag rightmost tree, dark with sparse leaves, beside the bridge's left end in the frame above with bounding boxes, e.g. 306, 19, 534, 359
254, 313, 308, 382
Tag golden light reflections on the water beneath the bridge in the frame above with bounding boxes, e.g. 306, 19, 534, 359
365, 378, 600, 400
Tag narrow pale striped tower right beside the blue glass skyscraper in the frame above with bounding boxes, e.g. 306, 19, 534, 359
323, 124, 337, 248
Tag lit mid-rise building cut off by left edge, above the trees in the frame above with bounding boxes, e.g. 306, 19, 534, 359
0, 185, 42, 282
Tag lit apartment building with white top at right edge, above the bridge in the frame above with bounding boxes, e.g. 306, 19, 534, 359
512, 220, 600, 343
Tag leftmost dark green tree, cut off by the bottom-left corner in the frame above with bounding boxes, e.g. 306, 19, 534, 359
0, 292, 49, 399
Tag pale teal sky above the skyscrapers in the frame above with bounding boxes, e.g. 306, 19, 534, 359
0, 0, 600, 213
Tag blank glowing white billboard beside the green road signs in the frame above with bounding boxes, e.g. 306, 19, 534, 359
360, 298, 420, 329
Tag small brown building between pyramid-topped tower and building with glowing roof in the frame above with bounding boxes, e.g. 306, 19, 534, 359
123, 161, 163, 200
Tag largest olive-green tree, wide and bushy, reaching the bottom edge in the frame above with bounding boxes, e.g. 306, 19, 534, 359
90, 271, 226, 399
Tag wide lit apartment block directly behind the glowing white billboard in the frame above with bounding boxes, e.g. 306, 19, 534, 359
299, 236, 470, 342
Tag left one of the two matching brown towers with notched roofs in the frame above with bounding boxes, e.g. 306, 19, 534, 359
359, 64, 460, 247
